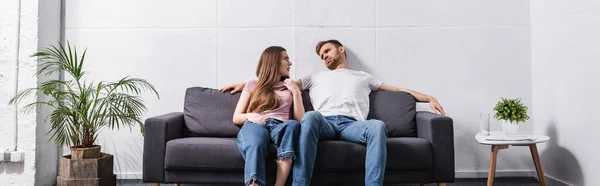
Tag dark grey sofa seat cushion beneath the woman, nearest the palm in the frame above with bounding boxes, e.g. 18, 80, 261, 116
165, 137, 277, 172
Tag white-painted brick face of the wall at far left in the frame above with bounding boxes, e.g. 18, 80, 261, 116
0, 0, 38, 185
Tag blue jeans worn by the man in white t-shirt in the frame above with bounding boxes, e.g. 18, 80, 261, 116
292, 111, 387, 186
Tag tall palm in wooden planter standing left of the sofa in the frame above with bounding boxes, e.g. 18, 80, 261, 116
9, 43, 159, 185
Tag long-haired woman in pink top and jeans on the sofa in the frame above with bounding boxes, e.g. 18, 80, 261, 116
233, 46, 304, 186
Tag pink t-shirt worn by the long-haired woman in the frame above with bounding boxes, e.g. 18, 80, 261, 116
243, 80, 292, 121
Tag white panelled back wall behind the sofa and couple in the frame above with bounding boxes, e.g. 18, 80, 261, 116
65, 0, 533, 178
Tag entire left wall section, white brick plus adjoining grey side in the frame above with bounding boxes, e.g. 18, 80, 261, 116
0, 0, 61, 185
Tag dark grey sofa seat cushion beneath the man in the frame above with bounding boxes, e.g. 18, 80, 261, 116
314, 137, 432, 171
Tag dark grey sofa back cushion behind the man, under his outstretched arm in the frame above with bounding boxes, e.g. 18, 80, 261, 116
302, 91, 417, 137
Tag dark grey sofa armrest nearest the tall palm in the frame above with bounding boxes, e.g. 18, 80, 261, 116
142, 112, 185, 183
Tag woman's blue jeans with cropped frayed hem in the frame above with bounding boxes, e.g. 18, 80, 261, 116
237, 118, 300, 186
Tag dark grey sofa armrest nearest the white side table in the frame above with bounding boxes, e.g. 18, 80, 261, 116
416, 111, 454, 182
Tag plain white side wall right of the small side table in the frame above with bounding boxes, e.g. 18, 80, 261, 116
531, 0, 600, 185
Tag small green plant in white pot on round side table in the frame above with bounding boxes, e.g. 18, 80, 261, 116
494, 98, 529, 134
